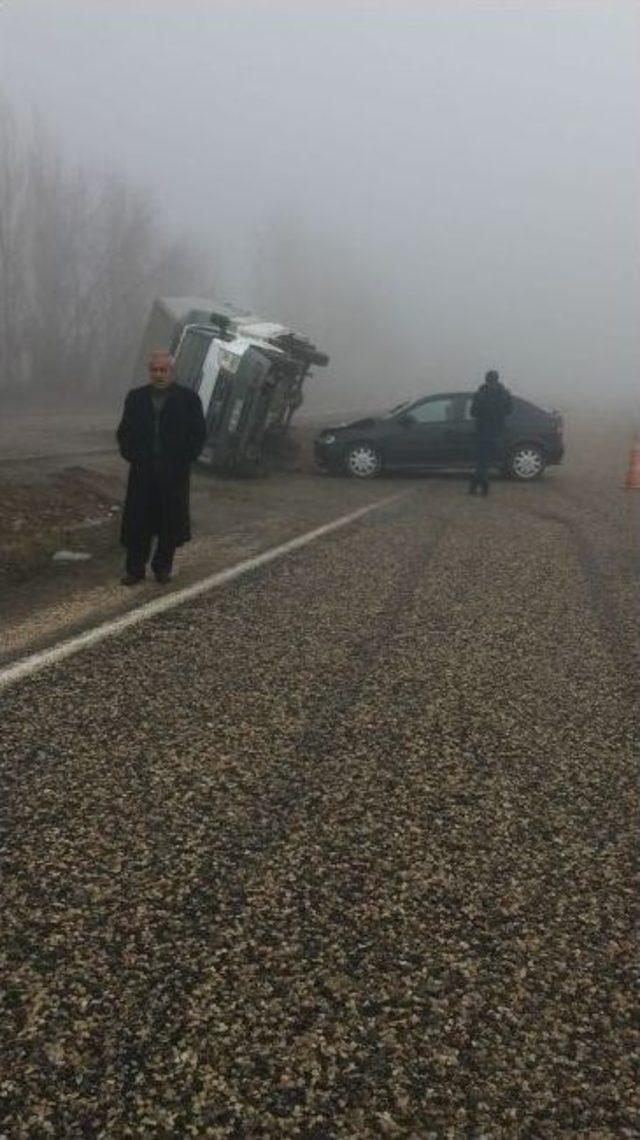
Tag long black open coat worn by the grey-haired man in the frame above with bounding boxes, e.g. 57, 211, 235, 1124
118, 384, 206, 546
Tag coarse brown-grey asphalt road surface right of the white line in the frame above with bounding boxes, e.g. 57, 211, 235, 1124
0, 467, 640, 1140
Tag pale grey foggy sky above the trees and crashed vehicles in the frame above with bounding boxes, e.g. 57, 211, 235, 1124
0, 0, 640, 419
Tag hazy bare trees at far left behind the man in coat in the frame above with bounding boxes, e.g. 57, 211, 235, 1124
0, 92, 210, 399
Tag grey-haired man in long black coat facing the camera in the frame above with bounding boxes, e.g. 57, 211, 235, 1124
118, 352, 206, 586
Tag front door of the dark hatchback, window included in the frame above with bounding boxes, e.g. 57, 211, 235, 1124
397, 396, 459, 467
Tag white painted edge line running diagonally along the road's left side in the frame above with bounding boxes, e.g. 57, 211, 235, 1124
0, 491, 407, 690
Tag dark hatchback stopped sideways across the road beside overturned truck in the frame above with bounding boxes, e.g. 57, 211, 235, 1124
315, 392, 564, 480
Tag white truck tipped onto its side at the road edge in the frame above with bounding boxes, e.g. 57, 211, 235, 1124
135, 298, 329, 474
